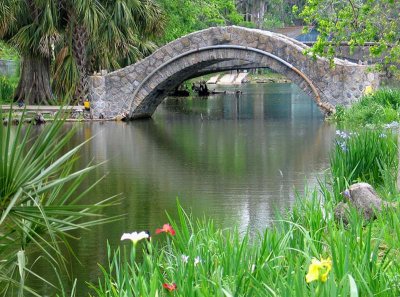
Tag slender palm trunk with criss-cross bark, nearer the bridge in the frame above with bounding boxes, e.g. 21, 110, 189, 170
72, 24, 89, 104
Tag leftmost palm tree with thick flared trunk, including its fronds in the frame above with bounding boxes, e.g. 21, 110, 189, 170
0, 0, 60, 104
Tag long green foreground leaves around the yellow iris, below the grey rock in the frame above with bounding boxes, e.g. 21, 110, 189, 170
91, 191, 400, 297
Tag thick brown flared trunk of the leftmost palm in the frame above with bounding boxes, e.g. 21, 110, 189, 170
14, 55, 53, 105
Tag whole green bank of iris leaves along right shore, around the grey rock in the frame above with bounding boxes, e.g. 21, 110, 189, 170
90, 129, 400, 297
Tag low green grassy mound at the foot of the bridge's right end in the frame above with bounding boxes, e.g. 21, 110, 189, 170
331, 89, 400, 127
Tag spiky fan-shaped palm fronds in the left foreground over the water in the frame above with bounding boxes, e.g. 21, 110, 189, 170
0, 111, 120, 296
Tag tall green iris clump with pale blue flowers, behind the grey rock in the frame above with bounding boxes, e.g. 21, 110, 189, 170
330, 130, 398, 197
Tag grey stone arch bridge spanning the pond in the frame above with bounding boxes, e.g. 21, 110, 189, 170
90, 26, 379, 119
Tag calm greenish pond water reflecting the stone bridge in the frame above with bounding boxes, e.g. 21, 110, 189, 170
36, 84, 335, 296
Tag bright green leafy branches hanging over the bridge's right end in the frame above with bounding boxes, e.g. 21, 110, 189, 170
300, 0, 400, 70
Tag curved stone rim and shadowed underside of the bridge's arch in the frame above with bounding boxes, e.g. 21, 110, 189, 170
129, 45, 326, 119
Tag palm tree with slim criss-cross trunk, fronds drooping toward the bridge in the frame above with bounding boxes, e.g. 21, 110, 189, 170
55, 0, 164, 102
